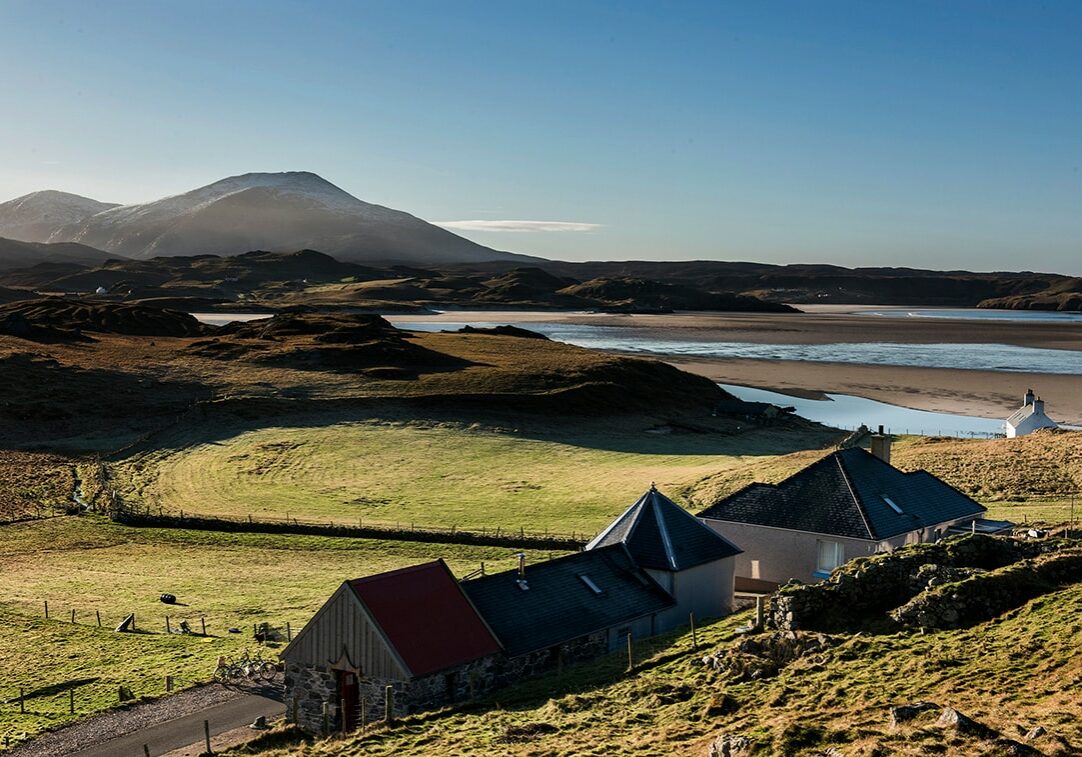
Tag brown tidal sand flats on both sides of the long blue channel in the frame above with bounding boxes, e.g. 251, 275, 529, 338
395, 305, 1082, 425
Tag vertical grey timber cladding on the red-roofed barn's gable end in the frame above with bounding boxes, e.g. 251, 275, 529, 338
282, 584, 409, 680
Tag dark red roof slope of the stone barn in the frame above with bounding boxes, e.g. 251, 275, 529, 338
349, 560, 500, 677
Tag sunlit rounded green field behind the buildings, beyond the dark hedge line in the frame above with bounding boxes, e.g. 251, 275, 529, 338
114, 422, 835, 534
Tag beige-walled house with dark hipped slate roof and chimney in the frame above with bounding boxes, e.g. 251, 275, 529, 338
699, 436, 995, 592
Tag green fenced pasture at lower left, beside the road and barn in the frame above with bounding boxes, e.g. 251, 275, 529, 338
0, 517, 547, 744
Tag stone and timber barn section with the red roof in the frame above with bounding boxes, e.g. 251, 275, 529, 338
281, 560, 500, 733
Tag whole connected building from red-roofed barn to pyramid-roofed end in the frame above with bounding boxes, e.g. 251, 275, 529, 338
281, 488, 740, 733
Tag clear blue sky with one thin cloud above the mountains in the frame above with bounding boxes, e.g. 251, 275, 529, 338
0, 0, 1082, 275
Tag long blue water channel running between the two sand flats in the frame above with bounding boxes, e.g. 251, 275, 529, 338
387, 317, 1082, 374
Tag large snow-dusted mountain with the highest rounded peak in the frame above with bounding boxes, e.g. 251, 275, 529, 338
28, 171, 531, 265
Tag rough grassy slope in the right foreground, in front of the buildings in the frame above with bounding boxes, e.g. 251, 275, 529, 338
223, 585, 1082, 757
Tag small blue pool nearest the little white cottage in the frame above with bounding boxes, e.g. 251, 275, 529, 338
718, 384, 1004, 437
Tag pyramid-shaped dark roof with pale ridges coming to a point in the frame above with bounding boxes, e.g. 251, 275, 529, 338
586, 486, 742, 571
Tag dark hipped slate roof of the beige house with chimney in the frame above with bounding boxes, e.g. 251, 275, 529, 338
699, 448, 985, 541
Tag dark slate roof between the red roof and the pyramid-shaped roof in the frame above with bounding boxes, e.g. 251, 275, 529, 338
461, 544, 675, 656
